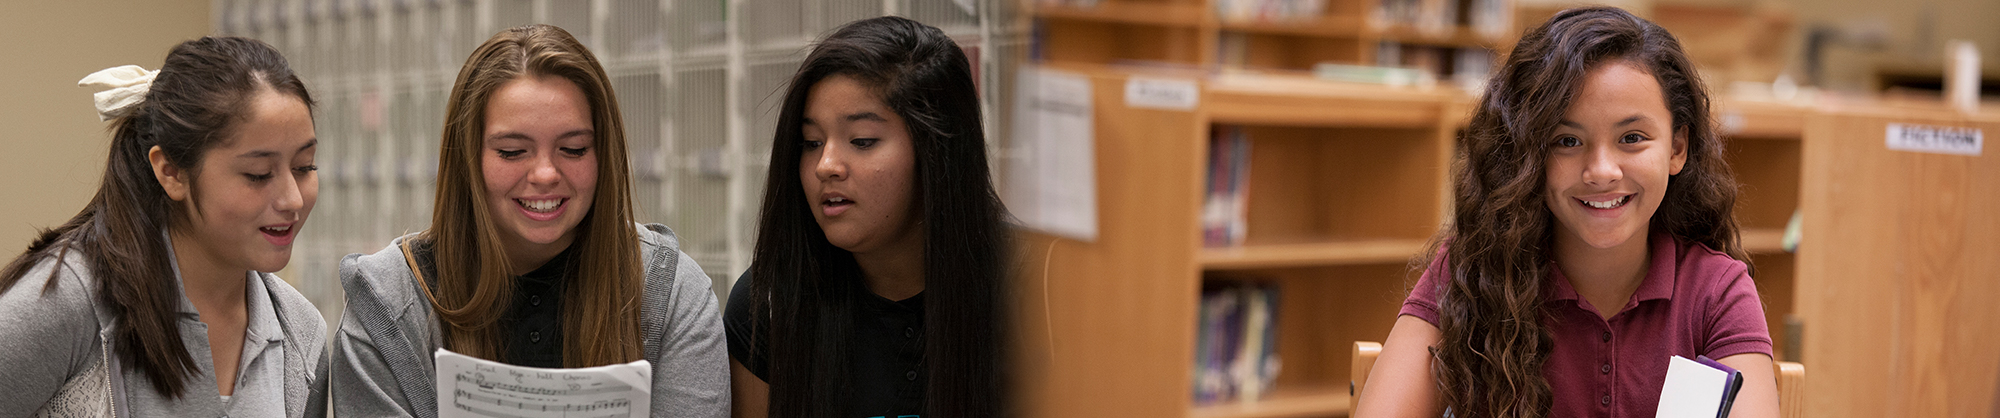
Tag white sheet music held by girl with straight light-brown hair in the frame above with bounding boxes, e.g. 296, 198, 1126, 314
434, 348, 652, 418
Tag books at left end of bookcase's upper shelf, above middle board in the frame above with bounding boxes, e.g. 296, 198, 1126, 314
1202, 126, 1250, 246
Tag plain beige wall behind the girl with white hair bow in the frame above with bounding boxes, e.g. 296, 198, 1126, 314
0, 0, 208, 253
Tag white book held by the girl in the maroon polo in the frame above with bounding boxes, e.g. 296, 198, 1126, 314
1654, 356, 1744, 418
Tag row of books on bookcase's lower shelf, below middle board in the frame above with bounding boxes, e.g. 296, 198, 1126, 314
1194, 280, 1282, 404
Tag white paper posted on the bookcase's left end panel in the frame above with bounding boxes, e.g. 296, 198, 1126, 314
1004, 66, 1098, 242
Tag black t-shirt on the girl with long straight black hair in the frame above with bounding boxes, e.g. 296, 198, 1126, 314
722, 272, 930, 418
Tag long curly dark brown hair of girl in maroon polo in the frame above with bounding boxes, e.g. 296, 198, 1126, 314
1418, 8, 1750, 418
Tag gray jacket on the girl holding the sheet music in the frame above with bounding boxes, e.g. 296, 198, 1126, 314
332, 224, 730, 418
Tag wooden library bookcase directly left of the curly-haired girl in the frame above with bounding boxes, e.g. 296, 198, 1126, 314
1018, 64, 1464, 418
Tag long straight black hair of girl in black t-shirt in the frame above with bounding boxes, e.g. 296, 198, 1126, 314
748, 16, 1008, 418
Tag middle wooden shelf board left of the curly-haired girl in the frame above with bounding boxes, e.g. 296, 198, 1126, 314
1194, 240, 1428, 270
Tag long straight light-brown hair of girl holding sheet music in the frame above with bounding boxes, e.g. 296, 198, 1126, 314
416, 24, 646, 368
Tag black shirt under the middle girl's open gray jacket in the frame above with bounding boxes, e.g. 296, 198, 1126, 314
410, 240, 576, 368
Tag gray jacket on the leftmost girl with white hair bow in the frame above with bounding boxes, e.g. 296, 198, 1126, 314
0, 252, 328, 416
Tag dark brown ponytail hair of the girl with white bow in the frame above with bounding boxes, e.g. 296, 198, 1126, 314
0, 36, 312, 398
